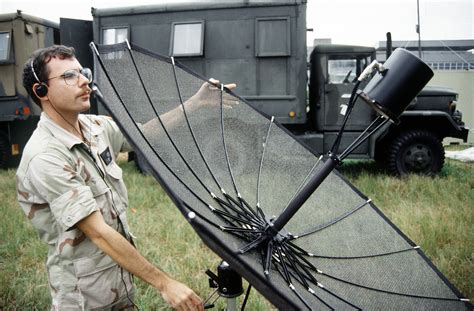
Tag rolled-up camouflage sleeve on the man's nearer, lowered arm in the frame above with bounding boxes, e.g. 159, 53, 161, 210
26, 153, 99, 231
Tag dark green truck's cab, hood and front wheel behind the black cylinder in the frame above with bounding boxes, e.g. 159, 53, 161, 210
301, 45, 468, 175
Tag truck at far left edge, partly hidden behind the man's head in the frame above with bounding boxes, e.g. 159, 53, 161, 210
0, 11, 59, 168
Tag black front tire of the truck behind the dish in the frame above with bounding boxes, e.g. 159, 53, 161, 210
387, 130, 444, 176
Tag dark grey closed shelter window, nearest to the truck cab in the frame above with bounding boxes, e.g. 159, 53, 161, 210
255, 17, 291, 57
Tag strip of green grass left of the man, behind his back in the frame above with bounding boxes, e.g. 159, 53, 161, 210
0, 170, 50, 310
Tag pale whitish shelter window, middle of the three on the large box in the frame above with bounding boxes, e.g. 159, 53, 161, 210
170, 21, 204, 56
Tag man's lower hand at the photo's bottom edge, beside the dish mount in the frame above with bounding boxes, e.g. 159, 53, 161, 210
161, 278, 204, 311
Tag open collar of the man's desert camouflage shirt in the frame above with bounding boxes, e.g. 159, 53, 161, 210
38, 111, 103, 149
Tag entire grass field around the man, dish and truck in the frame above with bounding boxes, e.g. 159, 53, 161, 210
0, 152, 474, 310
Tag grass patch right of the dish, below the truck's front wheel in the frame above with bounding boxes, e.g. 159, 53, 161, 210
341, 160, 474, 299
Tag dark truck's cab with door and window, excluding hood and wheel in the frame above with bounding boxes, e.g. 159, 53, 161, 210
308, 44, 375, 158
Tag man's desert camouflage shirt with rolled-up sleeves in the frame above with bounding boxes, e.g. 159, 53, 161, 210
17, 113, 133, 310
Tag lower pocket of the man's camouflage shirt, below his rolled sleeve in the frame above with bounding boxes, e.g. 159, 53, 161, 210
73, 253, 120, 309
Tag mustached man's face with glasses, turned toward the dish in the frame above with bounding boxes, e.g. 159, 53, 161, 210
47, 58, 90, 115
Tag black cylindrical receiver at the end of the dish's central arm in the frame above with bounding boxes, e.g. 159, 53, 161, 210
358, 48, 433, 123
